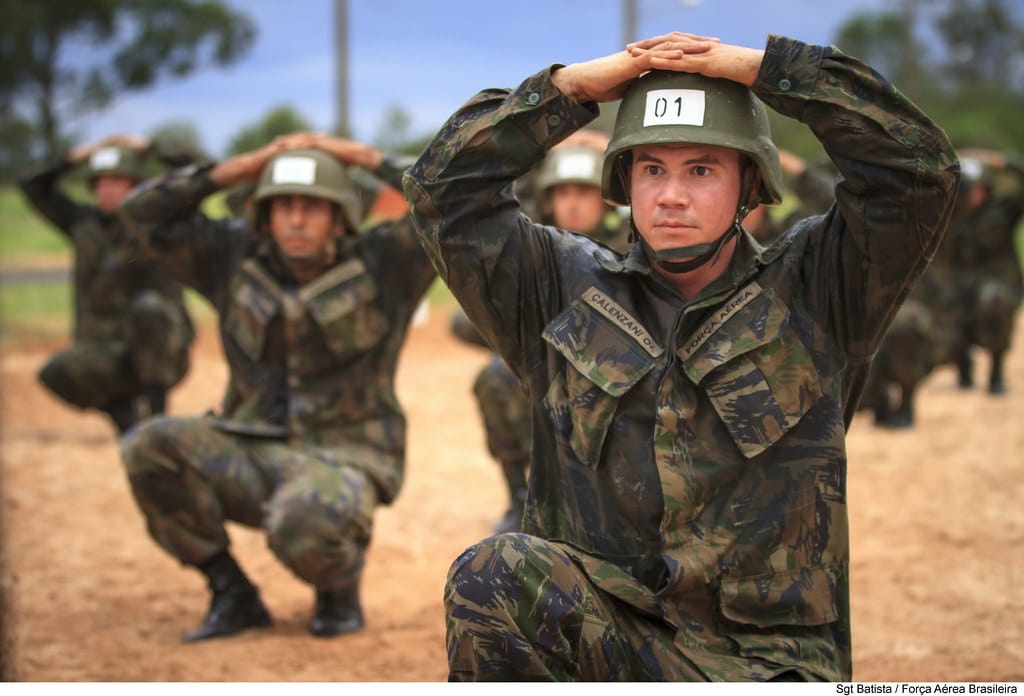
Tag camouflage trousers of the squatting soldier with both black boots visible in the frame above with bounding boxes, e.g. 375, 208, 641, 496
121, 417, 378, 590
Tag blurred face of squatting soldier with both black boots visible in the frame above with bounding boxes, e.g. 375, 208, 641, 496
270, 194, 343, 262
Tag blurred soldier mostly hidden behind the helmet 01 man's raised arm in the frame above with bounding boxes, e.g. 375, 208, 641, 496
452, 130, 630, 534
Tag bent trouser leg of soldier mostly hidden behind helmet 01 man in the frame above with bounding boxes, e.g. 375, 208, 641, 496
473, 357, 531, 491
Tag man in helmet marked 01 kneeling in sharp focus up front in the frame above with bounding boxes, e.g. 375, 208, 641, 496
404, 33, 957, 682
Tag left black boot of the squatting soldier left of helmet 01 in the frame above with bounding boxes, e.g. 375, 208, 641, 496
181, 551, 271, 643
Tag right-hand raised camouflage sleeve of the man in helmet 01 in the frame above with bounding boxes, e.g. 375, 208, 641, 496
754, 36, 959, 362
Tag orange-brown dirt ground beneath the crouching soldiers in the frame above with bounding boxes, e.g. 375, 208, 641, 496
0, 310, 1024, 682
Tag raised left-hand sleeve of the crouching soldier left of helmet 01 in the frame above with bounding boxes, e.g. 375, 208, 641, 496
120, 164, 247, 307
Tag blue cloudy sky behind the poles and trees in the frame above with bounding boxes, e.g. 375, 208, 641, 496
68, 0, 888, 157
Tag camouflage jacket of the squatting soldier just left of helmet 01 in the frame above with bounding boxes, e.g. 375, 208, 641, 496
122, 160, 435, 503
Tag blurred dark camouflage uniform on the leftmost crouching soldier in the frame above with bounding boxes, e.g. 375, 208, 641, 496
20, 154, 195, 423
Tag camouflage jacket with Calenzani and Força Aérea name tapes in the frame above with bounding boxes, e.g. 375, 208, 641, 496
404, 36, 958, 681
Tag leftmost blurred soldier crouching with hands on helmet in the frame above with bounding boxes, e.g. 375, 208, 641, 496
19, 134, 195, 433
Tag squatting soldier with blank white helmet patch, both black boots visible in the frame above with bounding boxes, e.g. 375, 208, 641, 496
122, 133, 435, 642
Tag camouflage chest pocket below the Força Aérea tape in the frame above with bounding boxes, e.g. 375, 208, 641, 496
678, 288, 821, 458
